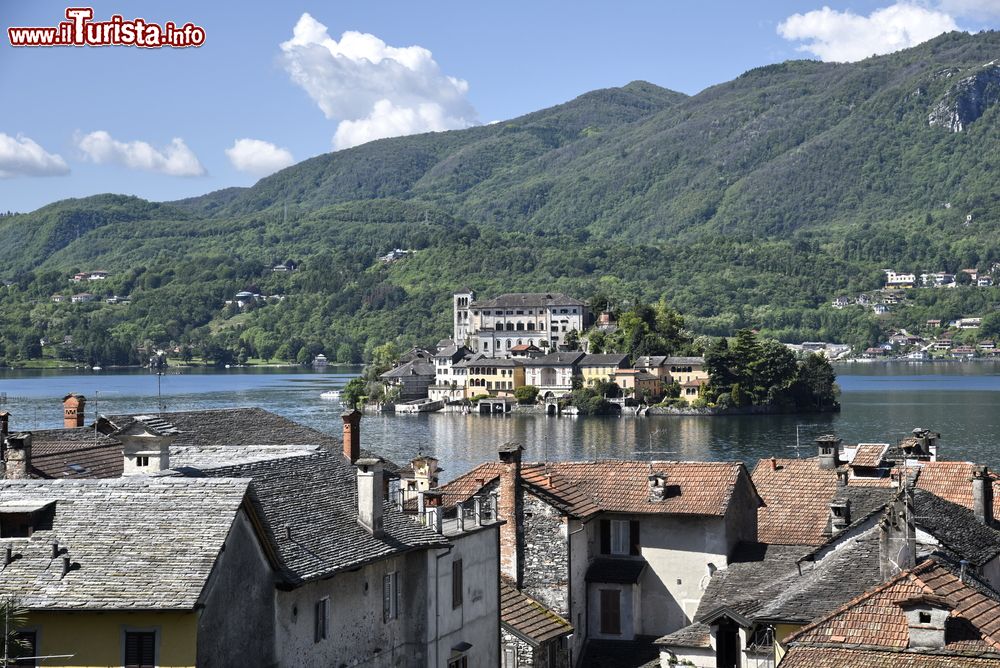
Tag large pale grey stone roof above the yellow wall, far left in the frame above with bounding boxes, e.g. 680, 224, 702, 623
0, 477, 249, 610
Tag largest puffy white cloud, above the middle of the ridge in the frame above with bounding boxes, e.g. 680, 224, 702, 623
281, 14, 477, 149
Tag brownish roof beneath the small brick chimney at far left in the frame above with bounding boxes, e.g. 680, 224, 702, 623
30, 427, 124, 479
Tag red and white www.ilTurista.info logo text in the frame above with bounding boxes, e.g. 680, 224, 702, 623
7, 7, 205, 49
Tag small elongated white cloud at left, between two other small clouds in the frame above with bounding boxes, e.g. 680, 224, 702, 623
76, 130, 205, 176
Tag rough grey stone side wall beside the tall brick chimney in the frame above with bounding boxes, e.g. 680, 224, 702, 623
523, 492, 569, 617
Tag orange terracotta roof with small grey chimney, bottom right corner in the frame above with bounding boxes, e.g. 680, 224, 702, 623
782, 558, 1000, 666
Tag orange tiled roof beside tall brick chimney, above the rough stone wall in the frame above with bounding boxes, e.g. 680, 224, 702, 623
441, 460, 749, 518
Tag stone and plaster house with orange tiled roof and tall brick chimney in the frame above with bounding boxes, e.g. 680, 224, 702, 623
441, 444, 759, 661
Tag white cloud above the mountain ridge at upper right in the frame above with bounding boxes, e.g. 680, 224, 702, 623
778, 2, 958, 62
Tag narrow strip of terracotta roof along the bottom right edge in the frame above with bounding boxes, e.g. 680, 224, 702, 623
781, 647, 1000, 668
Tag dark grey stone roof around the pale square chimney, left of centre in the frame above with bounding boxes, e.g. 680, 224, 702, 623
184, 452, 449, 584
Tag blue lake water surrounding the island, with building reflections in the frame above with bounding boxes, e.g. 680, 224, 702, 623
0, 362, 1000, 481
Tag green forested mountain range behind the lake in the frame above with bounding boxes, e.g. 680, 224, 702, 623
0, 32, 1000, 361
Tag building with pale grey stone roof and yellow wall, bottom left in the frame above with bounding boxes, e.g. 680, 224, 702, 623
0, 476, 274, 667
